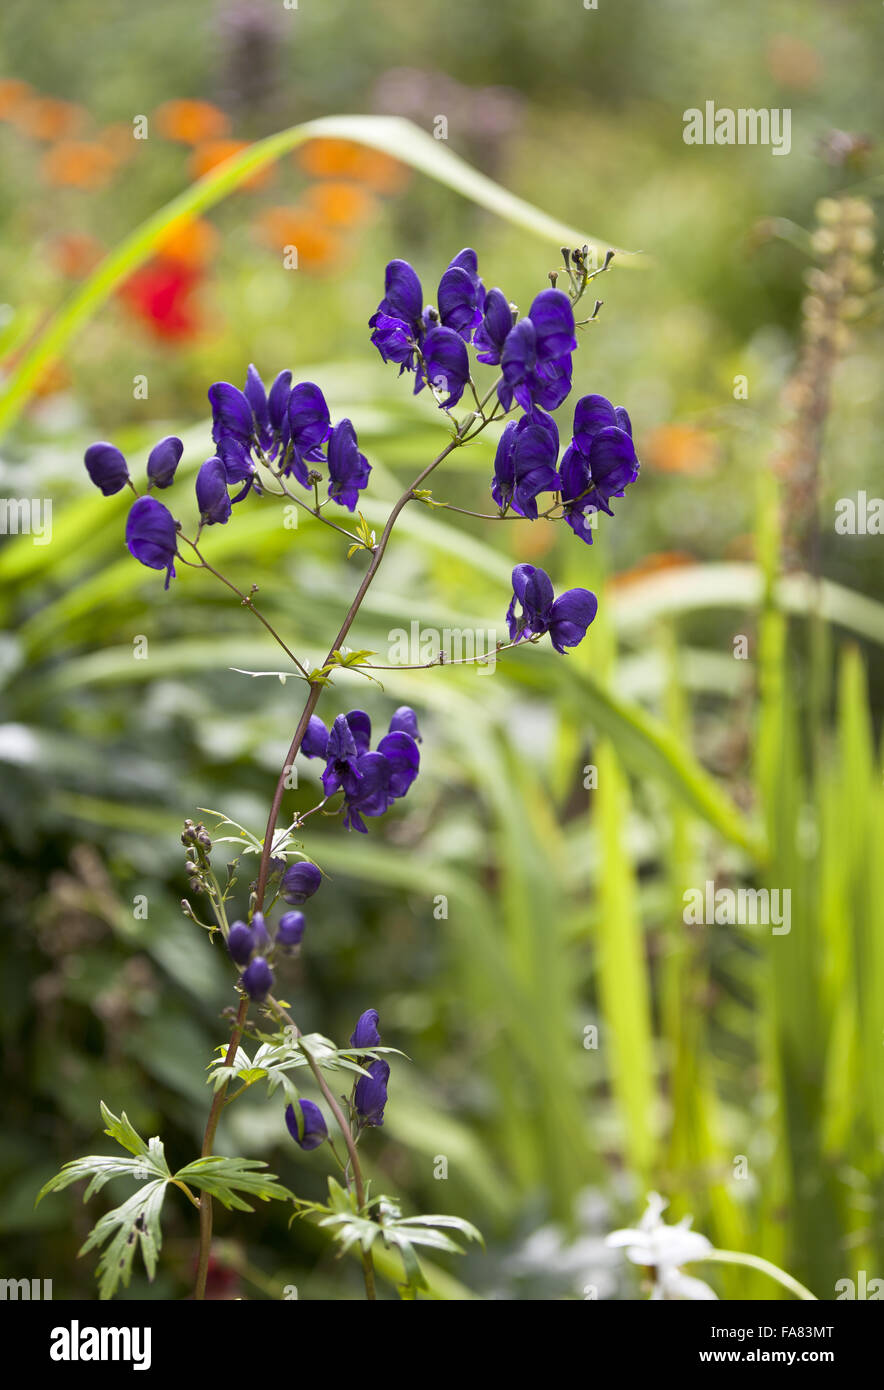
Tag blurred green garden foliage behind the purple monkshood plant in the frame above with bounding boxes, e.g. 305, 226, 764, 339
0, 0, 884, 1298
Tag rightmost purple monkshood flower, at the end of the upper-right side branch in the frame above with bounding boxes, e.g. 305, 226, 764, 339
560, 396, 639, 545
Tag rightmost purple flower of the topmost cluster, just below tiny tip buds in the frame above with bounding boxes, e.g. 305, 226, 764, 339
498, 289, 577, 410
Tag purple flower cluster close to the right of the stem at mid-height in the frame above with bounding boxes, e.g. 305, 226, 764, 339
301, 705, 421, 828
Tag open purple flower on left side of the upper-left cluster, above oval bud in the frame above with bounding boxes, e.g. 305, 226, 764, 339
208, 366, 292, 502
